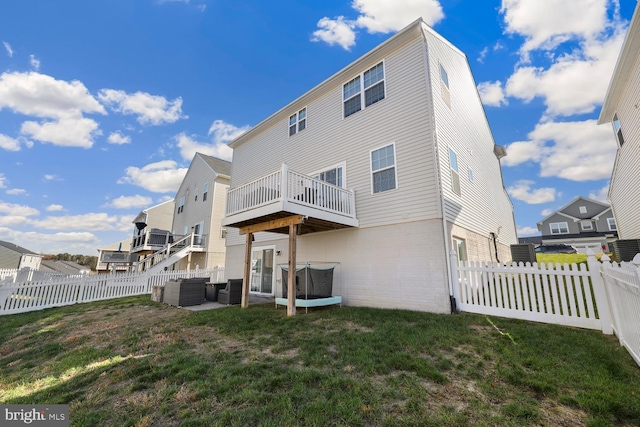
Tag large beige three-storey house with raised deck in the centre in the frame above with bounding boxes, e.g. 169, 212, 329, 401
223, 19, 517, 313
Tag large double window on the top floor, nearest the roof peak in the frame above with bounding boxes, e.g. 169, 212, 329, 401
342, 62, 385, 118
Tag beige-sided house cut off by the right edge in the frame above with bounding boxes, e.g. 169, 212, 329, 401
598, 0, 640, 239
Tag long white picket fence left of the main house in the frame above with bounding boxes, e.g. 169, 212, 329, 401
0, 268, 224, 315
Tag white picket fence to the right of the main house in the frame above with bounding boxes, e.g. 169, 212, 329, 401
451, 251, 640, 365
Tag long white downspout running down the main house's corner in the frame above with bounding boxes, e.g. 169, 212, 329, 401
421, 24, 460, 313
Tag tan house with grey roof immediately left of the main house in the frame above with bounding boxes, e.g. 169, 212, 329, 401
171, 153, 231, 270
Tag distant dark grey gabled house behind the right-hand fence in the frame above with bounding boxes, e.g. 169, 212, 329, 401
538, 197, 618, 253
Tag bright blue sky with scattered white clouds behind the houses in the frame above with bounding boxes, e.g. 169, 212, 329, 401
0, 0, 636, 255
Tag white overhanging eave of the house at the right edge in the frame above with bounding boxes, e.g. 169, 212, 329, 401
598, 4, 640, 125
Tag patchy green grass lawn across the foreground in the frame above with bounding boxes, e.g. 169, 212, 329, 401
0, 296, 640, 427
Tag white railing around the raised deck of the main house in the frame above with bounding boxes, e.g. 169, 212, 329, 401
226, 164, 356, 218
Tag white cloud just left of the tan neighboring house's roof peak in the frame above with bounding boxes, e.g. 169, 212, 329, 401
118, 160, 187, 193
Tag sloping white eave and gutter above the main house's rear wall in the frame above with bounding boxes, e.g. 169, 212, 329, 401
228, 18, 428, 148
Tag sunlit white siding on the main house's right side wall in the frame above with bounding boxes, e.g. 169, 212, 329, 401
422, 28, 518, 249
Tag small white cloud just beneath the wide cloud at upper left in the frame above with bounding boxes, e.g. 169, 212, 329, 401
20, 115, 101, 148
